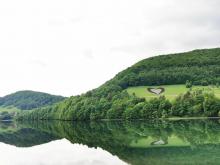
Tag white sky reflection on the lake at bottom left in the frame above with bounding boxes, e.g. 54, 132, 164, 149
0, 139, 126, 165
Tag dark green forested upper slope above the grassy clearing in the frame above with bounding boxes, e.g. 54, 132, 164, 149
111, 48, 220, 88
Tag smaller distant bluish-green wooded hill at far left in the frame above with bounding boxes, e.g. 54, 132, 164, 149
0, 90, 64, 110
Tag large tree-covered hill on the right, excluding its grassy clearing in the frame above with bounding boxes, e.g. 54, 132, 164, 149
19, 48, 220, 120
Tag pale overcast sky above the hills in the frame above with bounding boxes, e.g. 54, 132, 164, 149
0, 0, 220, 96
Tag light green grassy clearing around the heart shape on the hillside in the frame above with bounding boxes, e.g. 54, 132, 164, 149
127, 85, 220, 100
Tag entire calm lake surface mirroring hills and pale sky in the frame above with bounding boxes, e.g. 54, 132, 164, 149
0, 120, 220, 165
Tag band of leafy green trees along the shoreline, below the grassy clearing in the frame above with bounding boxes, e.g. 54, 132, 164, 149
18, 87, 220, 120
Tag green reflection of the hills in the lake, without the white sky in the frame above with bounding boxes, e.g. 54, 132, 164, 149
0, 120, 220, 165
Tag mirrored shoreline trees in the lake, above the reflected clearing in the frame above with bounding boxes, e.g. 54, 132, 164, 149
0, 120, 220, 147
